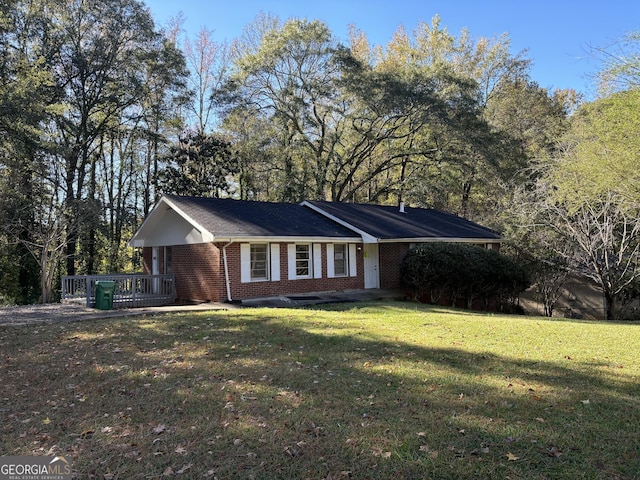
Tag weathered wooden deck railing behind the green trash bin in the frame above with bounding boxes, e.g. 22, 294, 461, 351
62, 274, 176, 308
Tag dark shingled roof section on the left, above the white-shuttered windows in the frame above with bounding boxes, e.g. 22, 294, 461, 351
165, 195, 360, 239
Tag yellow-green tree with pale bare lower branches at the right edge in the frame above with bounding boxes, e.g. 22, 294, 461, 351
516, 90, 640, 319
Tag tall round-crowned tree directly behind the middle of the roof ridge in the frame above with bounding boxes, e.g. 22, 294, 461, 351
220, 20, 339, 201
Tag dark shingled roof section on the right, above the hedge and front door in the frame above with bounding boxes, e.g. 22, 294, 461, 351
307, 201, 500, 240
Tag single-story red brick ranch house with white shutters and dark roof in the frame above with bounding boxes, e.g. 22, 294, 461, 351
129, 195, 501, 302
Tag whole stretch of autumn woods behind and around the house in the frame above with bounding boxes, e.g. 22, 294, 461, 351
0, 0, 640, 318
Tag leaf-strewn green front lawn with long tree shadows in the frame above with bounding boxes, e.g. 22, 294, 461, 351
0, 302, 640, 480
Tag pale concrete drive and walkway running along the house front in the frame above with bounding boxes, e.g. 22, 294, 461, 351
0, 289, 402, 326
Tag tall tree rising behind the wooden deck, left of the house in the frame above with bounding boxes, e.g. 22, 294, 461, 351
40, 0, 188, 275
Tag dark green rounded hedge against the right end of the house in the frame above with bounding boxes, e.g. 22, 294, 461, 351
400, 243, 531, 311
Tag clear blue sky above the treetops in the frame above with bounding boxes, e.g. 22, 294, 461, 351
144, 0, 640, 96
